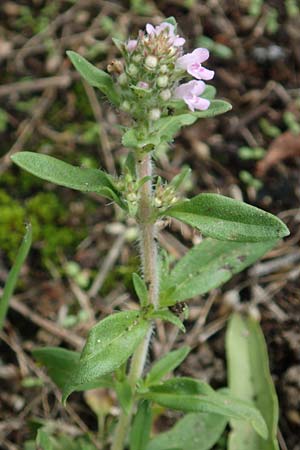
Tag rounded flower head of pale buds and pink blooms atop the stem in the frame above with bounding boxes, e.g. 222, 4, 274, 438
109, 22, 214, 121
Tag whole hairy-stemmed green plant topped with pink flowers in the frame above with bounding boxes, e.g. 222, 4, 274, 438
12, 18, 289, 450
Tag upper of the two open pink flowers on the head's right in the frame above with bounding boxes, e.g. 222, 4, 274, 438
176, 48, 215, 80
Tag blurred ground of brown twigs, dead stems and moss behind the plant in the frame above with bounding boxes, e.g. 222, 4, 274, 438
0, 0, 300, 450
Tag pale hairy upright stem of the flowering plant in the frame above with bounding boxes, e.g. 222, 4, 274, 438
111, 153, 159, 450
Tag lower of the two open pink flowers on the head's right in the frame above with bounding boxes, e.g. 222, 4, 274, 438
174, 80, 210, 112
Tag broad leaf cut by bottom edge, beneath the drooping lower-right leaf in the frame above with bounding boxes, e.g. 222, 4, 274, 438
147, 413, 227, 450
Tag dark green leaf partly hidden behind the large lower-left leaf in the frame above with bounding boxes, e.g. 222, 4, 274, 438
32, 347, 113, 391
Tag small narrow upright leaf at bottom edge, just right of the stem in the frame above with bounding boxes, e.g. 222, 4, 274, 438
129, 400, 152, 450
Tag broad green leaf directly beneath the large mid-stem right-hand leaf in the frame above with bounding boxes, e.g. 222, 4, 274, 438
160, 239, 278, 306
